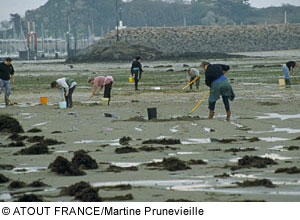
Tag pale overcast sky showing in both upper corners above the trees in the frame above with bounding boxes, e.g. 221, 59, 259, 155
0, 0, 300, 21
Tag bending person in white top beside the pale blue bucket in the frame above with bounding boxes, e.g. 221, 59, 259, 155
51, 77, 77, 108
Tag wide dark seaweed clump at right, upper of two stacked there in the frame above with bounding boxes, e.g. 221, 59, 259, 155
231, 155, 277, 170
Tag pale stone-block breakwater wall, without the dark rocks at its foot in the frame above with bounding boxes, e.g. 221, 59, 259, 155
99, 24, 300, 53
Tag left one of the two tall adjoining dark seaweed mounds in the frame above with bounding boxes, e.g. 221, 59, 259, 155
48, 156, 85, 176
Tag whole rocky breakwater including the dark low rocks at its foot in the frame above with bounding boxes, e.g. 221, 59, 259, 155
67, 24, 300, 62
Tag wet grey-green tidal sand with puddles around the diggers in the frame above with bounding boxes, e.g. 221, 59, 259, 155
0, 51, 300, 202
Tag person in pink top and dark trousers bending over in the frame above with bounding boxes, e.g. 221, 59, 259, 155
88, 76, 114, 105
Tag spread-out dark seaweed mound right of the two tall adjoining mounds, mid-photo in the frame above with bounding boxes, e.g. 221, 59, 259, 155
147, 157, 191, 171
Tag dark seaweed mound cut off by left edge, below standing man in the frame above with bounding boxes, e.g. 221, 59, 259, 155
0, 115, 24, 133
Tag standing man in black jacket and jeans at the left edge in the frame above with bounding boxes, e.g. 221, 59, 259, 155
0, 57, 15, 106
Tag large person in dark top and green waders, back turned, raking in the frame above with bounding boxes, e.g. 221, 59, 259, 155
200, 61, 235, 121
